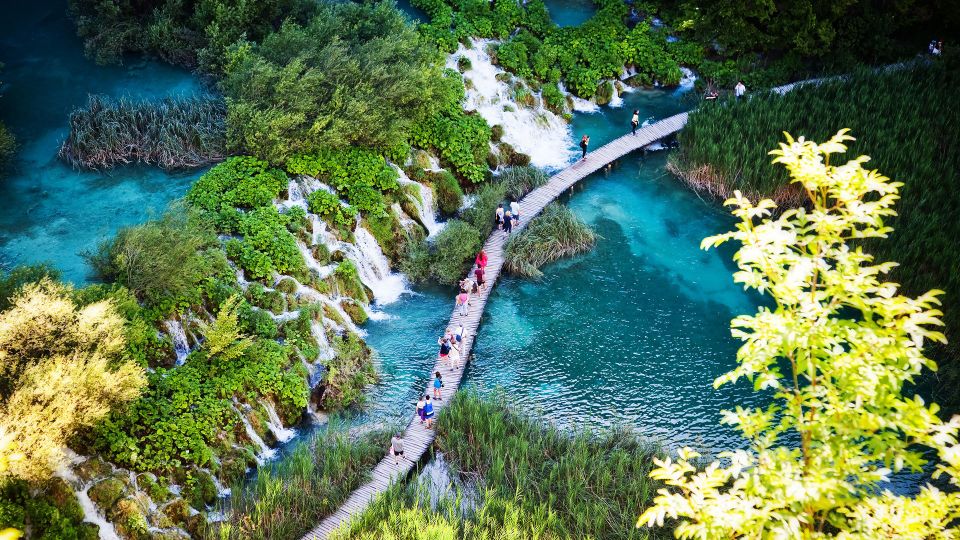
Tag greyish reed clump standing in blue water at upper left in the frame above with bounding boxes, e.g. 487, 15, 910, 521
58, 95, 226, 169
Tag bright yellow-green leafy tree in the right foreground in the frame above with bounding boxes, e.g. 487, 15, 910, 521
640, 130, 960, 538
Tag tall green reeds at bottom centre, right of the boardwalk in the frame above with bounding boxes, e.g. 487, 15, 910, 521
339, 391, 658, 540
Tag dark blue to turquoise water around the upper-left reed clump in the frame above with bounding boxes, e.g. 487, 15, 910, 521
0, 0, 200, 282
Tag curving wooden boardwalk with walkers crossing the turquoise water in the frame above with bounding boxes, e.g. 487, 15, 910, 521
303, 113, 687, 540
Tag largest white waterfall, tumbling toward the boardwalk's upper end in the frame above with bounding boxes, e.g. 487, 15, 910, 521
446, 39, 575, 169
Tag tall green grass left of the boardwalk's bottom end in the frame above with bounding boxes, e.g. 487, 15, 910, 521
205, 429, 390, 540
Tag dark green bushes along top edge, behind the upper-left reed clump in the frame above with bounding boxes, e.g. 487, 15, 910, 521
69, 0, 316, 72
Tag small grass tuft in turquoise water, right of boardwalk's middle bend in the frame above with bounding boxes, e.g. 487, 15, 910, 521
504, 203, 597, 278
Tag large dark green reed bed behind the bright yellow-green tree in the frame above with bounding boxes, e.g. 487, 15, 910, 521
671, 63, 960, 406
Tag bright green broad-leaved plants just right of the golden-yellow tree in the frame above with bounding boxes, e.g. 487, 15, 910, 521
95, 340, 307, 479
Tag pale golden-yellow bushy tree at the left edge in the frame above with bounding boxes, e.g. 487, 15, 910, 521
0, 279, 146, 480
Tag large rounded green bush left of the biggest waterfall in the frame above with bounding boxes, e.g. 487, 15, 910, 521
222, 3, 445, 163
